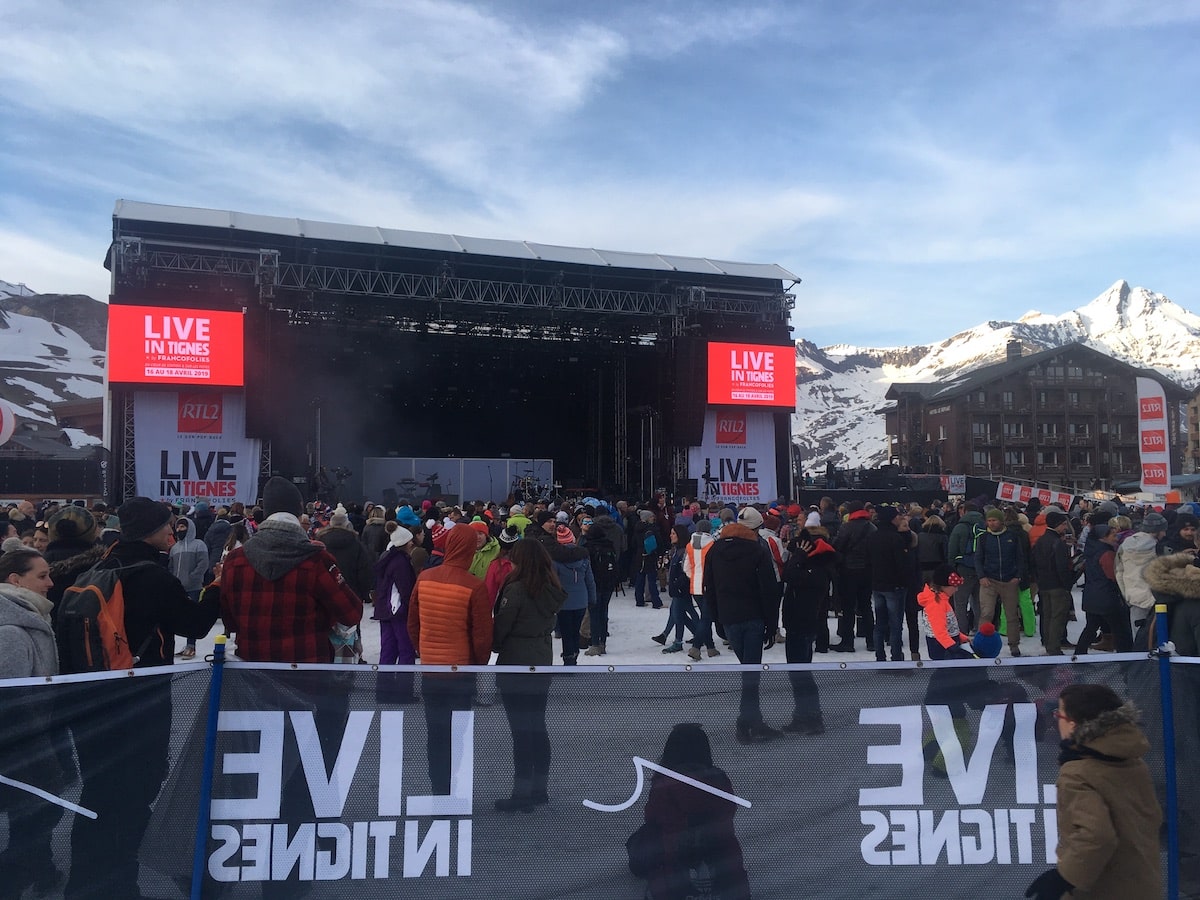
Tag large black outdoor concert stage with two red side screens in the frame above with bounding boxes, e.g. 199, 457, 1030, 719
106, 200, 798, 502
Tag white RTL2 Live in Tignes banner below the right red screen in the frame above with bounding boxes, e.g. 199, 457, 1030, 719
688, 407, 775, 503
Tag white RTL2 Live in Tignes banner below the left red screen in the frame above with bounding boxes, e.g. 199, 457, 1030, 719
133, 391, 262, 506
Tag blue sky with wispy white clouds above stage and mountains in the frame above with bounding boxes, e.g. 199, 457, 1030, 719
0, 0, 1200, 346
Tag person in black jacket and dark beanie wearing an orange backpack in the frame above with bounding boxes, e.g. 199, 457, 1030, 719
56, 497, 220, 900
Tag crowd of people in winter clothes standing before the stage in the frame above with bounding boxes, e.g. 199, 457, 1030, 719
0, 489, 1200, 898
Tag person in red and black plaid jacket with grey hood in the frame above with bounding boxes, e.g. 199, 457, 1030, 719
221, 476, 362, 662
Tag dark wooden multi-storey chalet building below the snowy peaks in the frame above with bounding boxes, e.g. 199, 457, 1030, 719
883, 342, 1190, 491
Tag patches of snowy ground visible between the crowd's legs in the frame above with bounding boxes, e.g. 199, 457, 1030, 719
176, 587, 1099, 666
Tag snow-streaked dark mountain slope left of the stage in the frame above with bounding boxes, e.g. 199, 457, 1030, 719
0, 290, 108, 448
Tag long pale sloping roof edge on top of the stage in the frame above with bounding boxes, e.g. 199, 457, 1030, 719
113, 200, 799, 282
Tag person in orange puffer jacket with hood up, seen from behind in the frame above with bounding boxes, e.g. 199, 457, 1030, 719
408, 526, 492, 796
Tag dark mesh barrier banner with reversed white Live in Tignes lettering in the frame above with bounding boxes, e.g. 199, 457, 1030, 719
0, 656, 1180, 900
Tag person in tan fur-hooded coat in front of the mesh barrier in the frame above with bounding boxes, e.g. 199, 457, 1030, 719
1025, 684, 1163, 900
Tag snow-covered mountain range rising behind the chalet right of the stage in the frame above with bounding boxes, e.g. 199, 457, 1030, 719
792, 281, 1200, 470
